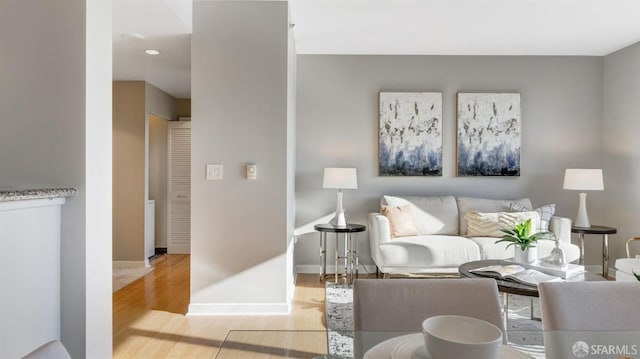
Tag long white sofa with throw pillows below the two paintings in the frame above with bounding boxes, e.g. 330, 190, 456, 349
368, 196, 580, 276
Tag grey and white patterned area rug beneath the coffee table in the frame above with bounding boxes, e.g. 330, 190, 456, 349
325, 283, 545, 359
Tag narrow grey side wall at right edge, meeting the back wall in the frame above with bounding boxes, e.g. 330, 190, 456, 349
602, 43, 640, 266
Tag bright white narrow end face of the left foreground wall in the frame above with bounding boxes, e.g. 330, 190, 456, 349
85, 1, 113, 359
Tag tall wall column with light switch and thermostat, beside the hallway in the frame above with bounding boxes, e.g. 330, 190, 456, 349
189, 1, 292, 314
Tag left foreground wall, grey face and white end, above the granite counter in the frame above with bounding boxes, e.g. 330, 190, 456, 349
0, 0, 111, 358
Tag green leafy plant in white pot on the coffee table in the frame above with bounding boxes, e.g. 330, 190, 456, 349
496, 218, 554, 263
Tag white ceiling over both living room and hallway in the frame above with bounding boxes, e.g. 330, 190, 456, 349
113, 0, 640, 98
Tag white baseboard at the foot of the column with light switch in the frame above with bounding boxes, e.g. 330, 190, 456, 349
187, 303, 291, 317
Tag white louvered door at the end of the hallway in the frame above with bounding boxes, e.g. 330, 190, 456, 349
167, 121, 191, 254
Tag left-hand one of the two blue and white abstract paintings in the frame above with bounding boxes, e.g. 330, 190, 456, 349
379, 92, 442, 176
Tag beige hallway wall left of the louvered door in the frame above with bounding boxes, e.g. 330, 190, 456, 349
113, 81, 178, 263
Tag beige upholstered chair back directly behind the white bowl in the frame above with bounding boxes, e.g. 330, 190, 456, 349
353, 278, 506, 358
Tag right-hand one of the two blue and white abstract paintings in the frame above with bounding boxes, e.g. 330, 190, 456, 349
458, 93, 522, 176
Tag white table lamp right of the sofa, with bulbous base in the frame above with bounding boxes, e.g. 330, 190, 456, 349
562, 168, 604, 228
